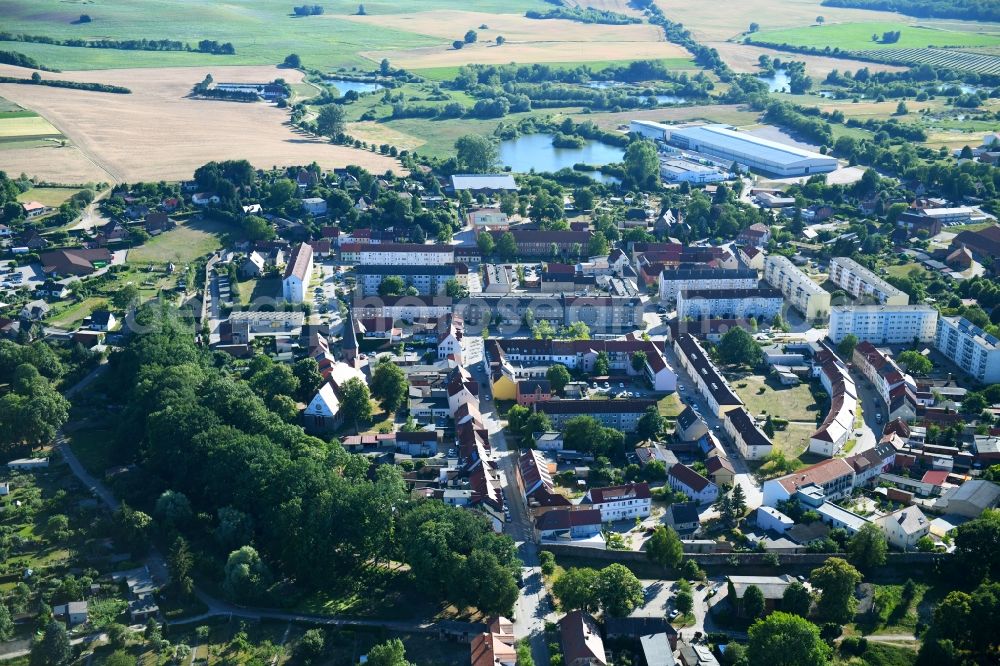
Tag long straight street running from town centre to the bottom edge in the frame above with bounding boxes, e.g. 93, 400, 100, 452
473, 364, 556, 664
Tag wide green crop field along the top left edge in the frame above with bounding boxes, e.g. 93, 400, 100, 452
0, 0, 544, 70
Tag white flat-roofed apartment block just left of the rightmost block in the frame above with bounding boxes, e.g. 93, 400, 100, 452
830, 305, 938, 345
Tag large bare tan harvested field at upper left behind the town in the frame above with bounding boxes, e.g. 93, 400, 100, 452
0, 65, 401, 183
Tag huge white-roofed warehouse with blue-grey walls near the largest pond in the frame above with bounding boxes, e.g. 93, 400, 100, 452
667, 125, 837, 176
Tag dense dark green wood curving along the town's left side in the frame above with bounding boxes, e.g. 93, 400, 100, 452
104, 304, 519, 613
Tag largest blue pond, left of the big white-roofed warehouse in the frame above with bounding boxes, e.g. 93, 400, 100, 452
500, 134, 625, 183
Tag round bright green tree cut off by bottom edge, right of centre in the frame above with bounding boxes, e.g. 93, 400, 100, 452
747, 612, 832, 666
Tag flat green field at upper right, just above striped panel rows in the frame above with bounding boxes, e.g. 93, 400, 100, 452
747, 22, 1000, 51
